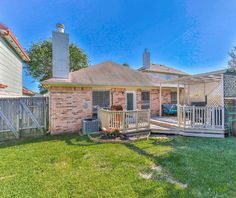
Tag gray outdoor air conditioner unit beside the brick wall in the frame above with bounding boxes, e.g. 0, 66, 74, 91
82, 118, 99, 134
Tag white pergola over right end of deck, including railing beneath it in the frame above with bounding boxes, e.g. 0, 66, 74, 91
160, 70, 227, 131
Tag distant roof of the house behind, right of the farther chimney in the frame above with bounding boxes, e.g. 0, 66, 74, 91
139, 64, 189, 75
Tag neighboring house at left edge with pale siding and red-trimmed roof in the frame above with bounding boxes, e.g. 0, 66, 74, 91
0, 24, 30, 97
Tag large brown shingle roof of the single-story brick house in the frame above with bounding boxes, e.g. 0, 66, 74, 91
43, 61, 164, 87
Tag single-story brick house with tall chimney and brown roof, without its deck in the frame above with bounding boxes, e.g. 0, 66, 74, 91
43, 26, 179, 133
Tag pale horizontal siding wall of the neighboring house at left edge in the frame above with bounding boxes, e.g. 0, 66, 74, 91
0, 38, 23, 97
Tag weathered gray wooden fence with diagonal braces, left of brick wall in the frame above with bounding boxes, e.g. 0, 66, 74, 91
0, 97, 48, 137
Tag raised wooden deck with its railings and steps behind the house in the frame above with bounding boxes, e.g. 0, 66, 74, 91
98, 107, 226, 138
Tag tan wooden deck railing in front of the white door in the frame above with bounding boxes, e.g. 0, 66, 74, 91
98, 109, 150, 132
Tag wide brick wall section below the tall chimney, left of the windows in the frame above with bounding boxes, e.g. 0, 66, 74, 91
50, 87, 92, 134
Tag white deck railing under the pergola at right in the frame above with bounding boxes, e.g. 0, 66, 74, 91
177, 105, 224, 129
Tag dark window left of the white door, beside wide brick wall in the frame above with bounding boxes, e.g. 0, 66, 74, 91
93, 91, 110, 113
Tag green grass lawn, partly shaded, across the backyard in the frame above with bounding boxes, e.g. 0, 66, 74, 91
0, 135, 236, 197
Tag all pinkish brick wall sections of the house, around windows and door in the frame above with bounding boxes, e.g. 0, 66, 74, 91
50, 87, 171, 134
